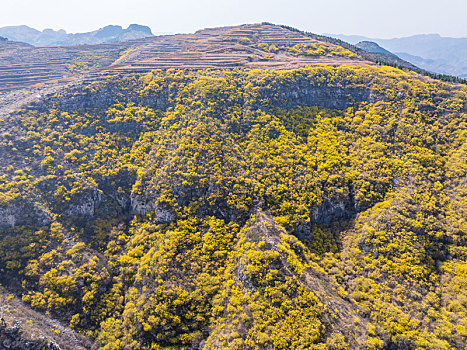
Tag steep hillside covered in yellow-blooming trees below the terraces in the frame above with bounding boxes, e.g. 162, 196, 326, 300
0, 64, 467, 349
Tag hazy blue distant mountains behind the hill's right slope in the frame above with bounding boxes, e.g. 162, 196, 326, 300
330, 34, 467, 78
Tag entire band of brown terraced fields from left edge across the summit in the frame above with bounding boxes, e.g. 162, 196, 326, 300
0, 24, 372, 92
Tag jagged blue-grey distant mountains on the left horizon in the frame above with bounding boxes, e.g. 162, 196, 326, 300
0, 24, 153, 46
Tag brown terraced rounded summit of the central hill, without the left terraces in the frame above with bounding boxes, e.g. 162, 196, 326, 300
106, 24, 370, 72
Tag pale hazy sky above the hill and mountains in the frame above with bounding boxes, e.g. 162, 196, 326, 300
0, 0, 467, 38
